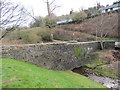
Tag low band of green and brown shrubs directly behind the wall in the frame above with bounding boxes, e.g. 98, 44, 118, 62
1, 27, 116, 45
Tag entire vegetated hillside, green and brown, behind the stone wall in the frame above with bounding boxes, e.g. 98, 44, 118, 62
2, 10, 120, 45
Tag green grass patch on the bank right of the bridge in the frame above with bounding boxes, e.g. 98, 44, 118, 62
86, 50, 120, 78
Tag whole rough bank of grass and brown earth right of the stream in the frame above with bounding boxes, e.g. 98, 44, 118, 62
86, 50, 120, 78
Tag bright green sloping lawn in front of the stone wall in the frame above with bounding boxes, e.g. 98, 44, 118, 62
1, 58, 106, 88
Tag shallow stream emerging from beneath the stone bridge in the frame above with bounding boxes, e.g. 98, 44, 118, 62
72, 67, 120, 90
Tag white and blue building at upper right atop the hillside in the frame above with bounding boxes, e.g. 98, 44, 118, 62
100, 3, 120, 13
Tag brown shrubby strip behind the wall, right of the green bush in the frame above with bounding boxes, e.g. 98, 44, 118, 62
54, 28, 95, 42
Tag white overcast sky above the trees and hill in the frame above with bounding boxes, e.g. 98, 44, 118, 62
11, 0, 116, 17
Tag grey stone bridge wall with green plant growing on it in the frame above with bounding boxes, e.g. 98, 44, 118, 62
1, 42, 114, 70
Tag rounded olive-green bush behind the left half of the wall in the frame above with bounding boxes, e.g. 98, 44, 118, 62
5, 28, 52, 44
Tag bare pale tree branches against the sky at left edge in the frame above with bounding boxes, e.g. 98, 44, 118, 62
0, 0, 26, 39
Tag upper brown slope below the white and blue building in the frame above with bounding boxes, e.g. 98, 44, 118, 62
56, 9, 120, 38
